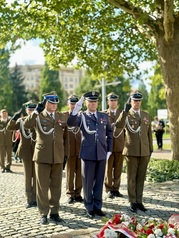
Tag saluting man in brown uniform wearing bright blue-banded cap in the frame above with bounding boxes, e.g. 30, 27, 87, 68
24, 91, 68, 225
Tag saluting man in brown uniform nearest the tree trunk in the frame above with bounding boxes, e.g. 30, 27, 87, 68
115, 92, 153, 212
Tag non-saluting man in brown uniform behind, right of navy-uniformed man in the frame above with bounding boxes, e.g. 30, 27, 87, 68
105, 93, 124, 198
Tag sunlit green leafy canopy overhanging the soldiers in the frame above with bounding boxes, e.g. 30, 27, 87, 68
0, 0, 156, 80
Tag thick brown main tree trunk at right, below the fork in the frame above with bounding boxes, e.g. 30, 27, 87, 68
157, 26, 179, 160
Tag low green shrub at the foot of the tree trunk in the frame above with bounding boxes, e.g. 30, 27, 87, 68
146, 159, 179, 182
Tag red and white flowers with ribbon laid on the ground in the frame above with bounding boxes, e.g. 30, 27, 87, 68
94, 214, 179, 238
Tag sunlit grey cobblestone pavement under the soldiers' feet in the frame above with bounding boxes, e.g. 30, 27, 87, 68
0, 152, 179, 238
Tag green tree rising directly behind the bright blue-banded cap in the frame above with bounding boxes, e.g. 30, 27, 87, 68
39, 63, 64, 110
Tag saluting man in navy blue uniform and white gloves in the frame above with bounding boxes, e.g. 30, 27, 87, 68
67, 92, 112, 218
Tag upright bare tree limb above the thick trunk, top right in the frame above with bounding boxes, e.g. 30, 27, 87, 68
163, 0, 174, 43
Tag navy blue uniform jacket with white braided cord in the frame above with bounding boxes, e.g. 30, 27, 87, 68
67, 111, 112, 161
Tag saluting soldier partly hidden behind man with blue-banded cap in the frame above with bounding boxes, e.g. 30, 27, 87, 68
7, 101, 37, 208
